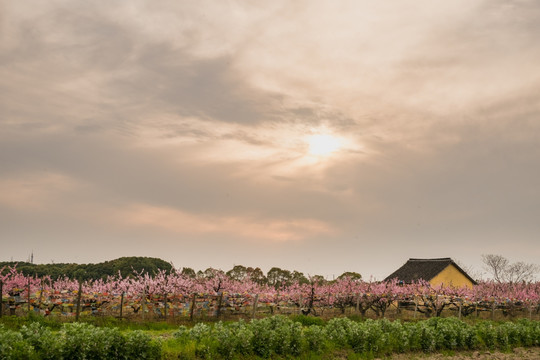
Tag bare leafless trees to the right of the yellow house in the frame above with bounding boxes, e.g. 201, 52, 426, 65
482, 254, 540, 283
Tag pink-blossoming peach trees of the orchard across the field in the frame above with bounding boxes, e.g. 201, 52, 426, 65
0, 267, 540, 316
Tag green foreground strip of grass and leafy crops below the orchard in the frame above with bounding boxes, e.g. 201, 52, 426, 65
0, 316, 540, 360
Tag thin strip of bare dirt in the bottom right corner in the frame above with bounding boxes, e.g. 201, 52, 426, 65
380, 347, 540, 360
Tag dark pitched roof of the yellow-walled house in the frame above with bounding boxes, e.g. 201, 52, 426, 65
384, 258, 476, 285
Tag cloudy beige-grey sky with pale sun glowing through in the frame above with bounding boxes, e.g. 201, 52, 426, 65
0, 0, 540, 279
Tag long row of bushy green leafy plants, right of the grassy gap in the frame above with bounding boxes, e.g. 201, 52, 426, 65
167, 316, 540, 359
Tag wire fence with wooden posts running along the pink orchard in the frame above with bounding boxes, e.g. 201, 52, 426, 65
0, 287, 540, 321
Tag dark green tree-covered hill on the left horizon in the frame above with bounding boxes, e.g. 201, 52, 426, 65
0, 256, 173, 280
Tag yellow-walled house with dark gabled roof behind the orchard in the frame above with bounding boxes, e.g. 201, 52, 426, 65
385, 258, 476, 288
